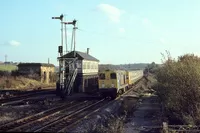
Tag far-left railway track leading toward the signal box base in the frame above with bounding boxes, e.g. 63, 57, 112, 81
0, 90, 55, 106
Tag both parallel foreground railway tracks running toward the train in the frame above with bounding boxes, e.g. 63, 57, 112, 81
0, 78, 142, 132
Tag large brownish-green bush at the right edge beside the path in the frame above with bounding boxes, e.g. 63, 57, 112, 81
156, 54, 200, 124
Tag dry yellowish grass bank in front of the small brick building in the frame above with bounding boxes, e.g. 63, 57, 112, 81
0, 77, 55, 90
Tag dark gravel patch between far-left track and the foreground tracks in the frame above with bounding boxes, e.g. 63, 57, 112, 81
0, 97, 62, 124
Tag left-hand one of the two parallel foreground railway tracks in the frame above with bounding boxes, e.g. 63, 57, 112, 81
0, 101, 94, 132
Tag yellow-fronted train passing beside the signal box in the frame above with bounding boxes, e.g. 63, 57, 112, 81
98, 69, 144, 99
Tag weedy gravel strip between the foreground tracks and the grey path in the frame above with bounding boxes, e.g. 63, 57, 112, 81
68, 79, 151, 133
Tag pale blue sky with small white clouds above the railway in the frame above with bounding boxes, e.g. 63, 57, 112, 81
0, 0, 200, 65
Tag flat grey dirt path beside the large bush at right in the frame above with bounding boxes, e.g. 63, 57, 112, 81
124, 94, 162, 133
